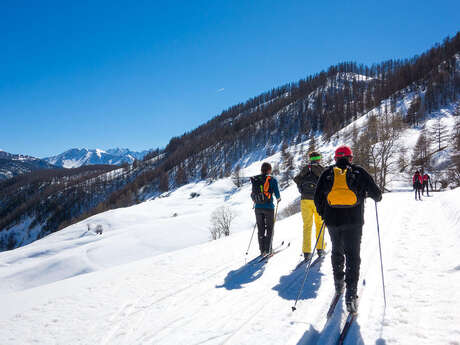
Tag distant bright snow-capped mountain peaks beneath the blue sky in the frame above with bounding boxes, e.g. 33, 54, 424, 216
44, 148, 149, 168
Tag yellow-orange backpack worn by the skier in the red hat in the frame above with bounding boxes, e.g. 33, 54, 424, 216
327, 167, 358, 208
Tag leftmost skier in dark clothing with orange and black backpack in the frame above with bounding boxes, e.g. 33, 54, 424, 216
251, 163, 281, 255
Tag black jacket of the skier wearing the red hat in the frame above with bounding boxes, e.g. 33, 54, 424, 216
314, 165, 382, 227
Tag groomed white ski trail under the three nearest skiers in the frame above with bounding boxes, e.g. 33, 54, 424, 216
0, 189, 460, 345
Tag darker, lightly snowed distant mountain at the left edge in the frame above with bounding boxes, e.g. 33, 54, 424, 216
0, 150, 56, 180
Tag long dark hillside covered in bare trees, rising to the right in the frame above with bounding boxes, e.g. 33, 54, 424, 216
0, 33, 460, 250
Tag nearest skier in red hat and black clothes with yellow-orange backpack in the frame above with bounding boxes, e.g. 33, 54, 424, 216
314, 146, 382, 313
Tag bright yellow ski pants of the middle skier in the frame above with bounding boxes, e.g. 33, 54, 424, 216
300, 200, 326, 253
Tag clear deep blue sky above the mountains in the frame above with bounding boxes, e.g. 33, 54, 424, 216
0, 0, 460, 157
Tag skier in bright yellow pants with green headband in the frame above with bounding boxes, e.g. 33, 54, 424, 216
294, 151, 325, 261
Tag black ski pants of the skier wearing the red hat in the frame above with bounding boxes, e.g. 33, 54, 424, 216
326, 224, 363, 296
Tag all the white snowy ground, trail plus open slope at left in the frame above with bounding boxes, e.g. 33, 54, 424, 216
0, 176, 460, 345
